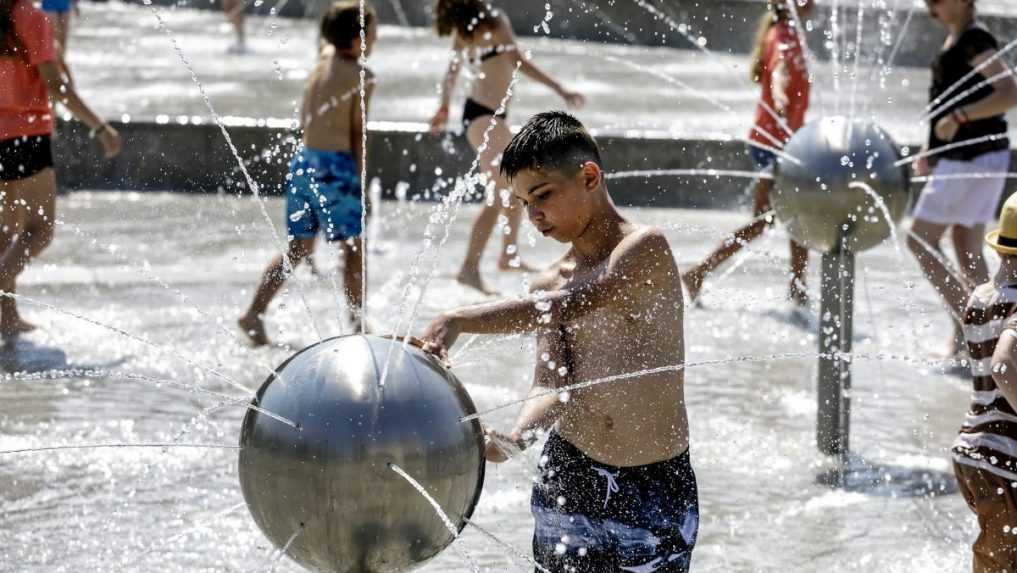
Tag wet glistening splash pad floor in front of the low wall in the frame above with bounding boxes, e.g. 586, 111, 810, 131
0, 192, 974, 572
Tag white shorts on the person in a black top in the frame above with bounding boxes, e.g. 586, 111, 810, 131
914, 150, 1010, 227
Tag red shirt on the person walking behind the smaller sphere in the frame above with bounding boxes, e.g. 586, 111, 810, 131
749, 21, 811, 147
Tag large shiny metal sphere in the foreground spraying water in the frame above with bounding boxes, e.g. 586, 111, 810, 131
239, 336, 484, 573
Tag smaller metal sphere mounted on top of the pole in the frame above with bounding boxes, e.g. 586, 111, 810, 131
772, 117, 909, 252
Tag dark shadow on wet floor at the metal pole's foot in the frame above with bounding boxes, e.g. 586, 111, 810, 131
816, 454, 958, 498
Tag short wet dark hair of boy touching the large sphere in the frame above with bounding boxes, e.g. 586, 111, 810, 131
501, 111, 602, 179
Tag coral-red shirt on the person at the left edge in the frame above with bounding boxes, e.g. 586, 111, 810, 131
0, 0, 56, 140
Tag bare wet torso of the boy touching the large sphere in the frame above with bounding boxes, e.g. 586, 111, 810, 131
538, 225, 689, 466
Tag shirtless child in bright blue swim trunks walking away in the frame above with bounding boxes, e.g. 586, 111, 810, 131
238, 0, 377, 345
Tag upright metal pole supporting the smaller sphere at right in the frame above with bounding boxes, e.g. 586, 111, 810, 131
816, 250, 854, 456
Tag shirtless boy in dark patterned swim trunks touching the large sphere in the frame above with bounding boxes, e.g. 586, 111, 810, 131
422, 112, 699, 573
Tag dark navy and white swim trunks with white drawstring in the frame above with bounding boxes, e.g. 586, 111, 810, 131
530, 434, 699, 573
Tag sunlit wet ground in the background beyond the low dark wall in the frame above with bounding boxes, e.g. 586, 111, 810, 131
69, 2, 1017, 144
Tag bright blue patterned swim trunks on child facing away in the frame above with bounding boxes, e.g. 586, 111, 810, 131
286, 148, 363, 241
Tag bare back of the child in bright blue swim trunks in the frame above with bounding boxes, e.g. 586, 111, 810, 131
301, 55, 372, 152
